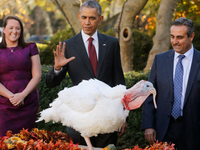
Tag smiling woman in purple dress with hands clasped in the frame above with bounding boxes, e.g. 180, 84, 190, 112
0, 16, 41, 137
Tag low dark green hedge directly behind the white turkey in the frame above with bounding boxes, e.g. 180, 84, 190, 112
36, 65, 148, 149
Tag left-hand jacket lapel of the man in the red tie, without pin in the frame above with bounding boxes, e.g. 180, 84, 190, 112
74, 33, 94, 76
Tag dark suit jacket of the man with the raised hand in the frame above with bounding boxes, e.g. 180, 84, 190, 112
46, 33, 125, 87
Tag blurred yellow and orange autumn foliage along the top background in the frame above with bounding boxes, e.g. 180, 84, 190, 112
0, 0, 200, 38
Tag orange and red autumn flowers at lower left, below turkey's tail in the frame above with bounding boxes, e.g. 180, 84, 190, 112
0, 128, 83, 150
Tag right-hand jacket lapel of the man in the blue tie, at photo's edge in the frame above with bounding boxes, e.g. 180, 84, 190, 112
184, 49, 200, 105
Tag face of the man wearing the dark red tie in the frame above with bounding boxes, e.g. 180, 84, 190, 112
78, 7, 103, 36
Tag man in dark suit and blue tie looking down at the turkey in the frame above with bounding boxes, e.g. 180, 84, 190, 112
142, 17, 200, 150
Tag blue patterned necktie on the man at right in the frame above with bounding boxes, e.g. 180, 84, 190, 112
172, 55, 185, 119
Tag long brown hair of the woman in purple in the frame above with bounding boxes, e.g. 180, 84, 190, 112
0, 15, 29, 48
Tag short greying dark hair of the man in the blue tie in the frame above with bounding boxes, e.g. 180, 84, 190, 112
171, 17, 194, 37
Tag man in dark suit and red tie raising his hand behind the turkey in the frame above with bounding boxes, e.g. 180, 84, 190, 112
46, 0, 126, 148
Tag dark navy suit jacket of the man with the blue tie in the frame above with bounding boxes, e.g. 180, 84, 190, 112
142, 50, 200, 150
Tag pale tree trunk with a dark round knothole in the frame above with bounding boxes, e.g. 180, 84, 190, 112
116, 0, 148, 72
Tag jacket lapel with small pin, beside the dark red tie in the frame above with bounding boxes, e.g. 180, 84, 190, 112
97, 33, 109, 78
